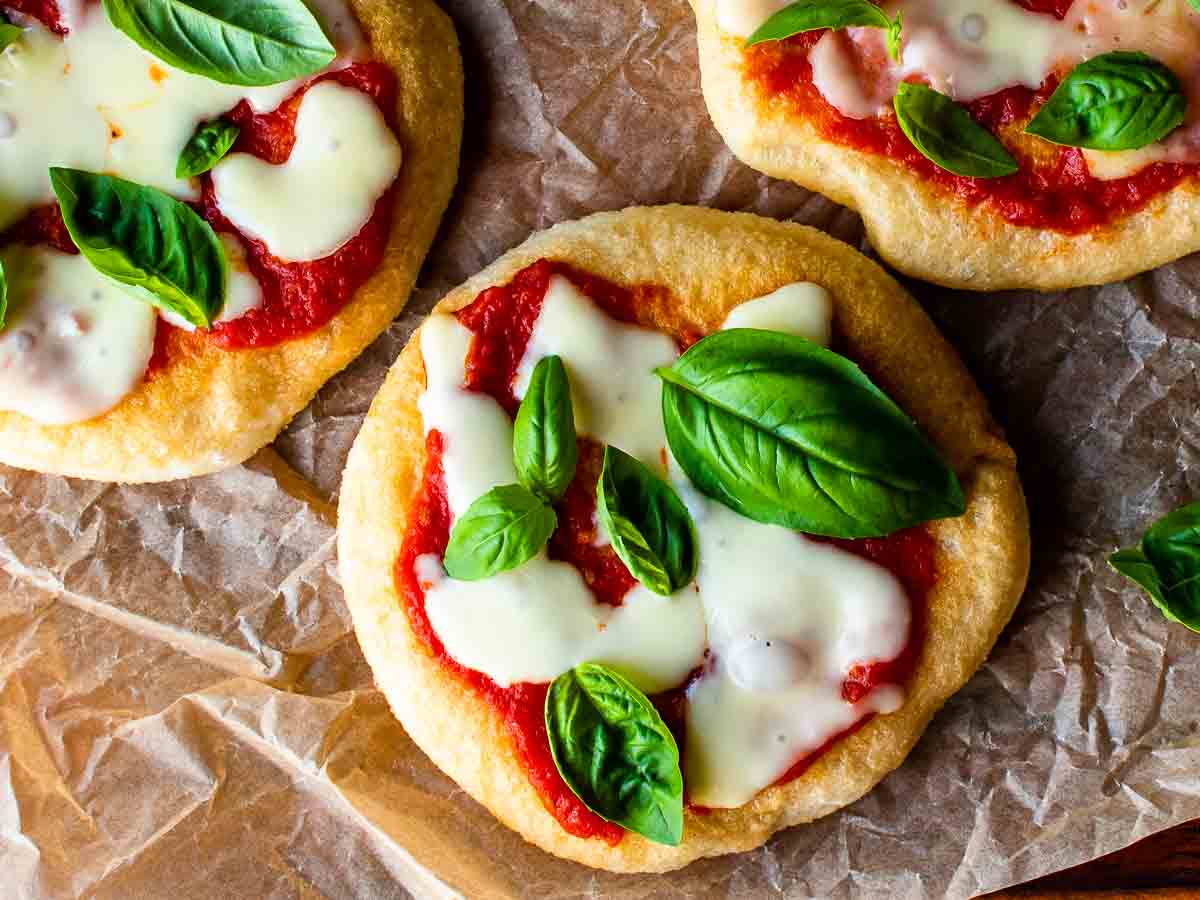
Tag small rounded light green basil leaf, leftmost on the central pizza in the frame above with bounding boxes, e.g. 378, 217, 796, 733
443, 485, 558, 581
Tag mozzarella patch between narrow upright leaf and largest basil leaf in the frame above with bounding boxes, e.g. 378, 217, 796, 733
514, 275, 679, 469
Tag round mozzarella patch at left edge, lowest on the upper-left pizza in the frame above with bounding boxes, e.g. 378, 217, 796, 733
0, 246, 156, 425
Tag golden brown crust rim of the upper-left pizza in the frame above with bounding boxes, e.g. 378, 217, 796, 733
0, 0, 462, 482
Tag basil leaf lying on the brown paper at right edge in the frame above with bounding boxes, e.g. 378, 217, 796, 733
1109, 503, 1200, 631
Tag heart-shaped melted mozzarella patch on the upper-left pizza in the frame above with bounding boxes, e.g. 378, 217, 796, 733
212, 82, 402, 262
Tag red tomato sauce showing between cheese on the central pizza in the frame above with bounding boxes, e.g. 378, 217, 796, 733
396, 259, 936, 844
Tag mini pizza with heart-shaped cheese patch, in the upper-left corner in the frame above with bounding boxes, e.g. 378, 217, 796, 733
0, 0, 462, 482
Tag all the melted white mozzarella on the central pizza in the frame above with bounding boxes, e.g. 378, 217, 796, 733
416, 278, 910, 806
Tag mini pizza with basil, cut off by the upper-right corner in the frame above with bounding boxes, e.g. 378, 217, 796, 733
691, 0, 1200, 290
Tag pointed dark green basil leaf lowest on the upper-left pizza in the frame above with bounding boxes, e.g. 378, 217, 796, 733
50, 168, 229, 328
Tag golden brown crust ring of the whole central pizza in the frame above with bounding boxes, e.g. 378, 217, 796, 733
338, 206, 1030, 871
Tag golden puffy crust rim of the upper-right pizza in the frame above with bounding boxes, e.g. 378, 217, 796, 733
691, 0, 1200, 290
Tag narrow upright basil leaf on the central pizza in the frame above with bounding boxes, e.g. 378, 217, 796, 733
512, 356, 580, 503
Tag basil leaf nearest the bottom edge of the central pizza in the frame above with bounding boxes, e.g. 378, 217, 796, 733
546, 662, 683, 847
